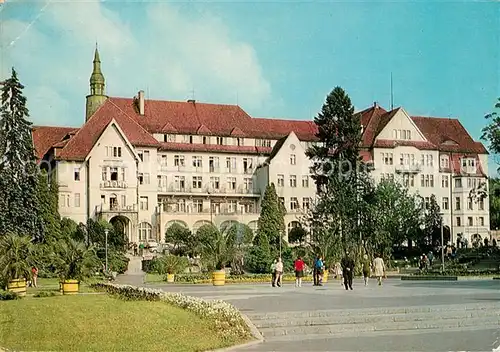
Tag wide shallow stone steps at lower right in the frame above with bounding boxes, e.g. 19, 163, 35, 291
247, 303, 500, 341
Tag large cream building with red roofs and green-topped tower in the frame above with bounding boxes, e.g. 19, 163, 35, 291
33, 50, 489, 246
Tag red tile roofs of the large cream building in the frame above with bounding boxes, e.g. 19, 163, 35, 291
33, 98, 487, 160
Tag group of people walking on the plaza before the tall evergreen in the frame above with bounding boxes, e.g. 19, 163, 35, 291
271, 252, 386, 290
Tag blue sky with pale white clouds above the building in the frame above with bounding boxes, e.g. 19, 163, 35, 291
0, 0, 500, 167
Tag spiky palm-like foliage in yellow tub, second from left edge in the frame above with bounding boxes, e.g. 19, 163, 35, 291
53, 238, 101, 281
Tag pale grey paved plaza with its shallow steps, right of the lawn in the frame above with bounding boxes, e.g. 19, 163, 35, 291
118, 264, 500, 352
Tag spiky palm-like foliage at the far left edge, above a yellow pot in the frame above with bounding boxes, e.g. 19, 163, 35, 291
0, 234, 34, 281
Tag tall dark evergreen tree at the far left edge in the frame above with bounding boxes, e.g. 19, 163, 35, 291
0, 68, 43, 240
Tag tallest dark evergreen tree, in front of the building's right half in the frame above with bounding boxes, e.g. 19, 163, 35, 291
306, 87, 364, 256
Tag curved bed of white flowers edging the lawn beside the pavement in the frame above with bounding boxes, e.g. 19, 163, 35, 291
91, 282, 251, 339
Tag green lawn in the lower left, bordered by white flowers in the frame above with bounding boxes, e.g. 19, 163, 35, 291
0, 295, 245, 352
